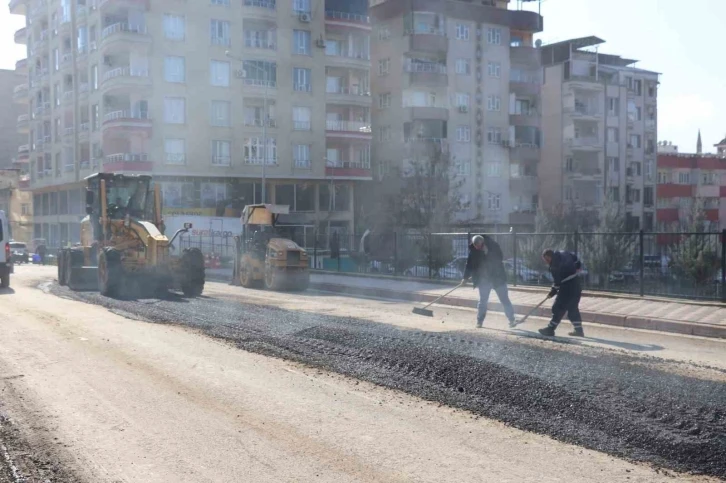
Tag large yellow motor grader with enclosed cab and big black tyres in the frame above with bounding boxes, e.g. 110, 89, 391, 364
58, 173, 205, 297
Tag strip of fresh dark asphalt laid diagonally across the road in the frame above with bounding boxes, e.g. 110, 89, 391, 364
52, 286, 726, 478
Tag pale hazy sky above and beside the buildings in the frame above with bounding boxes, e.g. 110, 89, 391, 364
0, 0, 726, 152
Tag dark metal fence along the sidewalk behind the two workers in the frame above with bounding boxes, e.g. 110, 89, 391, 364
312, 230, 726, 302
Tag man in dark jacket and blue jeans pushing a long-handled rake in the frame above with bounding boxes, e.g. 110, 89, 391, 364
461, 235, 514, 327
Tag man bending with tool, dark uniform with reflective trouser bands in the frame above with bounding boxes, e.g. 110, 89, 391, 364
539, 249, 585, 337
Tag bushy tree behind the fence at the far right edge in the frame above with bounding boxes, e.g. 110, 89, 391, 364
669, 199, 721, 285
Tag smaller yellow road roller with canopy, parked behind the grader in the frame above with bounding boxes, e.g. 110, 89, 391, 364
232, 205, 310, 290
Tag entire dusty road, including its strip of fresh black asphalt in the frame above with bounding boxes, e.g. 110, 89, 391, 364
0, 267, 726, 483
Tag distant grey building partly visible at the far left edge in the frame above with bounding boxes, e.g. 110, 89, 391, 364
0, 68, 29, 170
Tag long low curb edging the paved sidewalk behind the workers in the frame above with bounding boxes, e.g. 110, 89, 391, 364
207, 275, 726, 339
